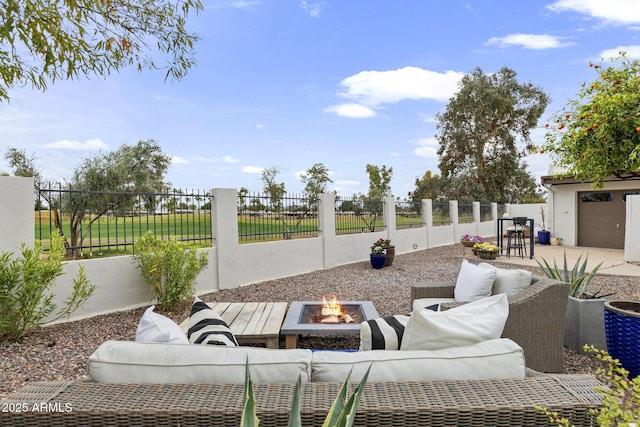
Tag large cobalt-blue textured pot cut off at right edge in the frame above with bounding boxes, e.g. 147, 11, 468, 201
604, 301, 640, 378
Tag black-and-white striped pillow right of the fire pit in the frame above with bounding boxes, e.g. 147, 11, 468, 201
360, 315, 409, 351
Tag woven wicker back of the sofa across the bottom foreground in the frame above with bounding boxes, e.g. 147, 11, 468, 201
0, 375, 602, 427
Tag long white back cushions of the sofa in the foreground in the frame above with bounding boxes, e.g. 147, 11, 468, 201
89, 338, 526, 384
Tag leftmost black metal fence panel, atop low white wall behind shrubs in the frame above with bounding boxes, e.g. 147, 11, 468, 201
35, 185, 212, 258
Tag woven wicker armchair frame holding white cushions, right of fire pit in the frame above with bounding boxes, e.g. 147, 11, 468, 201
410, 276, 569, 373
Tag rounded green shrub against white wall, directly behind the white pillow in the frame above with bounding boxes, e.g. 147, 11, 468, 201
133, 231, 208, 310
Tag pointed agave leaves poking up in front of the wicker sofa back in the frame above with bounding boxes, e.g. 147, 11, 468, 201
240, 364, 371, 427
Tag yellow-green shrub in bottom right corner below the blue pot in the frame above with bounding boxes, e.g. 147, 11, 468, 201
536, 345, 640, 427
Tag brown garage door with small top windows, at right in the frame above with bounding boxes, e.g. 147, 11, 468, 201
578, 190, 640, 249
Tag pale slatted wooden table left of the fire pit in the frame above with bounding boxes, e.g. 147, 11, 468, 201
180, 302, 288, 348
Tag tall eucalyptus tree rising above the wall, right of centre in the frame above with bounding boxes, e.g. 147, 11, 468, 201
436, 67, 549, 202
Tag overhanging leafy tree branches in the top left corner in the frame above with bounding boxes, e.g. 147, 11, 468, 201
0, 0, 203, 102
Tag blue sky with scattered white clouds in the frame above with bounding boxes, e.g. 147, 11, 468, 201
0, 0, 640, 197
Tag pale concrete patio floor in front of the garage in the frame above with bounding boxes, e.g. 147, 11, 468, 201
496, 244, 640, 277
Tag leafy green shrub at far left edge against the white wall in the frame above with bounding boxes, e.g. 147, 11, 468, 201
0, 238, 95, 341
